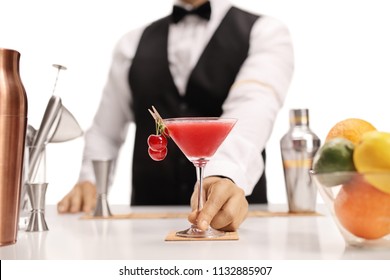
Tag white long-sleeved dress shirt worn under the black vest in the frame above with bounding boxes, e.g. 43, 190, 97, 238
79, 0, 294, 197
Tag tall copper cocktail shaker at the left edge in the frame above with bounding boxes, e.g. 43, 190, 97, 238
0, 48, 27, 246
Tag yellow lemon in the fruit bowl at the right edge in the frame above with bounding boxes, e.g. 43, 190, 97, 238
353, 131, 390, 194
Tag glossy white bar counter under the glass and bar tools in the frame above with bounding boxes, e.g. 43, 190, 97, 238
0, 205, 390, 260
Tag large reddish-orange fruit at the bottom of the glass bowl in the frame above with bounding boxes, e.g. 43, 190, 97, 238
334, 174, 390, 239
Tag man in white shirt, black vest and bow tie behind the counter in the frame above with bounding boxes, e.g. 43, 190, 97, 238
58, 0, 293, 230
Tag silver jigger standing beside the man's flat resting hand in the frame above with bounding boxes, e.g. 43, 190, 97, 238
92, 160, 112, 217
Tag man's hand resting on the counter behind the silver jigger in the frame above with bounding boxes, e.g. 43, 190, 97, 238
57, 181, 96, 213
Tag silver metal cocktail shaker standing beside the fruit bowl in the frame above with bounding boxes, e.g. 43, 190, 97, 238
280, 109, 321, 212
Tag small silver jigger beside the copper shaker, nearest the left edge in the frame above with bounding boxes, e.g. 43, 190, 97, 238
26, 183, 49, 231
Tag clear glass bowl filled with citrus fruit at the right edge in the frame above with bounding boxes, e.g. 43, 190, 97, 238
311, 119, 390, 248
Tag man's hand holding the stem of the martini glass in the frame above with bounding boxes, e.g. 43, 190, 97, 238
188, 177, 248, 231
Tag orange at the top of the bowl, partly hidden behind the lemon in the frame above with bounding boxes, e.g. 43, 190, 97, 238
325, 118, 376, 145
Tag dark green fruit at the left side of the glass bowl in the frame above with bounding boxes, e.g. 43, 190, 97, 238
313, 138, 356, 187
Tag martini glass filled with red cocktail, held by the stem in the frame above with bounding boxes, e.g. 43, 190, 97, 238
163, 117, 237, 238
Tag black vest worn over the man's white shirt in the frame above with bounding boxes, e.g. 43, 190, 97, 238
128, 7, 267, 205
